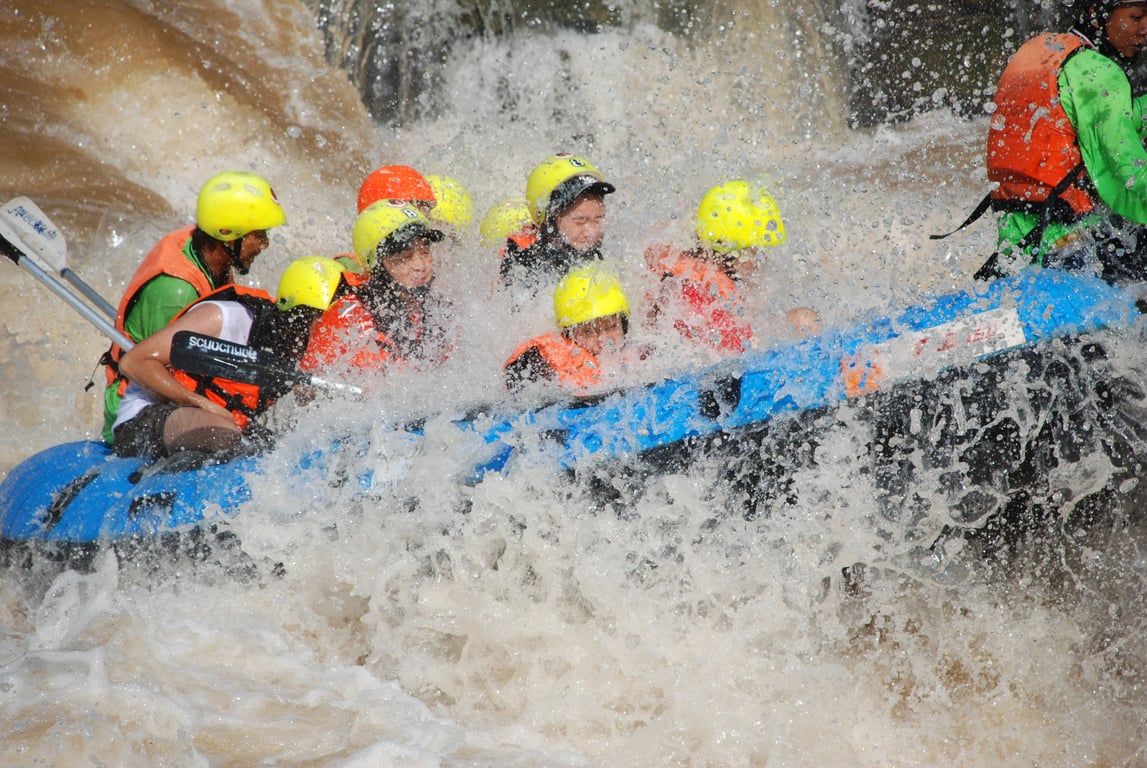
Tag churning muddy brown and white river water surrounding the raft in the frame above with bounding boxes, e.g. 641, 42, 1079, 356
0, 0, 1147, 768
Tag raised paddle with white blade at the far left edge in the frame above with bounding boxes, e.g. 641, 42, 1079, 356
0, 197, 133, 350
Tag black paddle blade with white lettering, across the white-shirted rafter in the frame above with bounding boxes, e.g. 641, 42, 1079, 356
171, 330, 362, 394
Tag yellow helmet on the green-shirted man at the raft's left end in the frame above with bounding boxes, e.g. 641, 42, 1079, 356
195, 171, 287, 242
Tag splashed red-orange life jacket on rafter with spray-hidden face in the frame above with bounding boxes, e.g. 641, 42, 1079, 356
645, 245, 752, 352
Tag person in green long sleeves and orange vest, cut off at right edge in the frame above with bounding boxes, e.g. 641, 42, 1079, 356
969, 0, 1147, 283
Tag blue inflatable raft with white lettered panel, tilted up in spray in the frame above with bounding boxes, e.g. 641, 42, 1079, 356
0, 268, 1140, 544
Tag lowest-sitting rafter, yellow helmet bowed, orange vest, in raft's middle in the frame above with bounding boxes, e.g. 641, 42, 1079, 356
502, 265, 630, 392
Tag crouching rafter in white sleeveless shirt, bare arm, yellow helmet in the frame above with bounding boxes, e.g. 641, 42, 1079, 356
114, 257, 344, 459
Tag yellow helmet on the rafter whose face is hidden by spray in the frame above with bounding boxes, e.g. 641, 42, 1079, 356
697, 180, 785, 253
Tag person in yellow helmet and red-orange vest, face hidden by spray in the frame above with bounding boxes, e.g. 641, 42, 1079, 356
645, 180, 814, 353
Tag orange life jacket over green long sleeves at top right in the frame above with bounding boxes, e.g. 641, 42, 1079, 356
988, 34, 1095, 215
